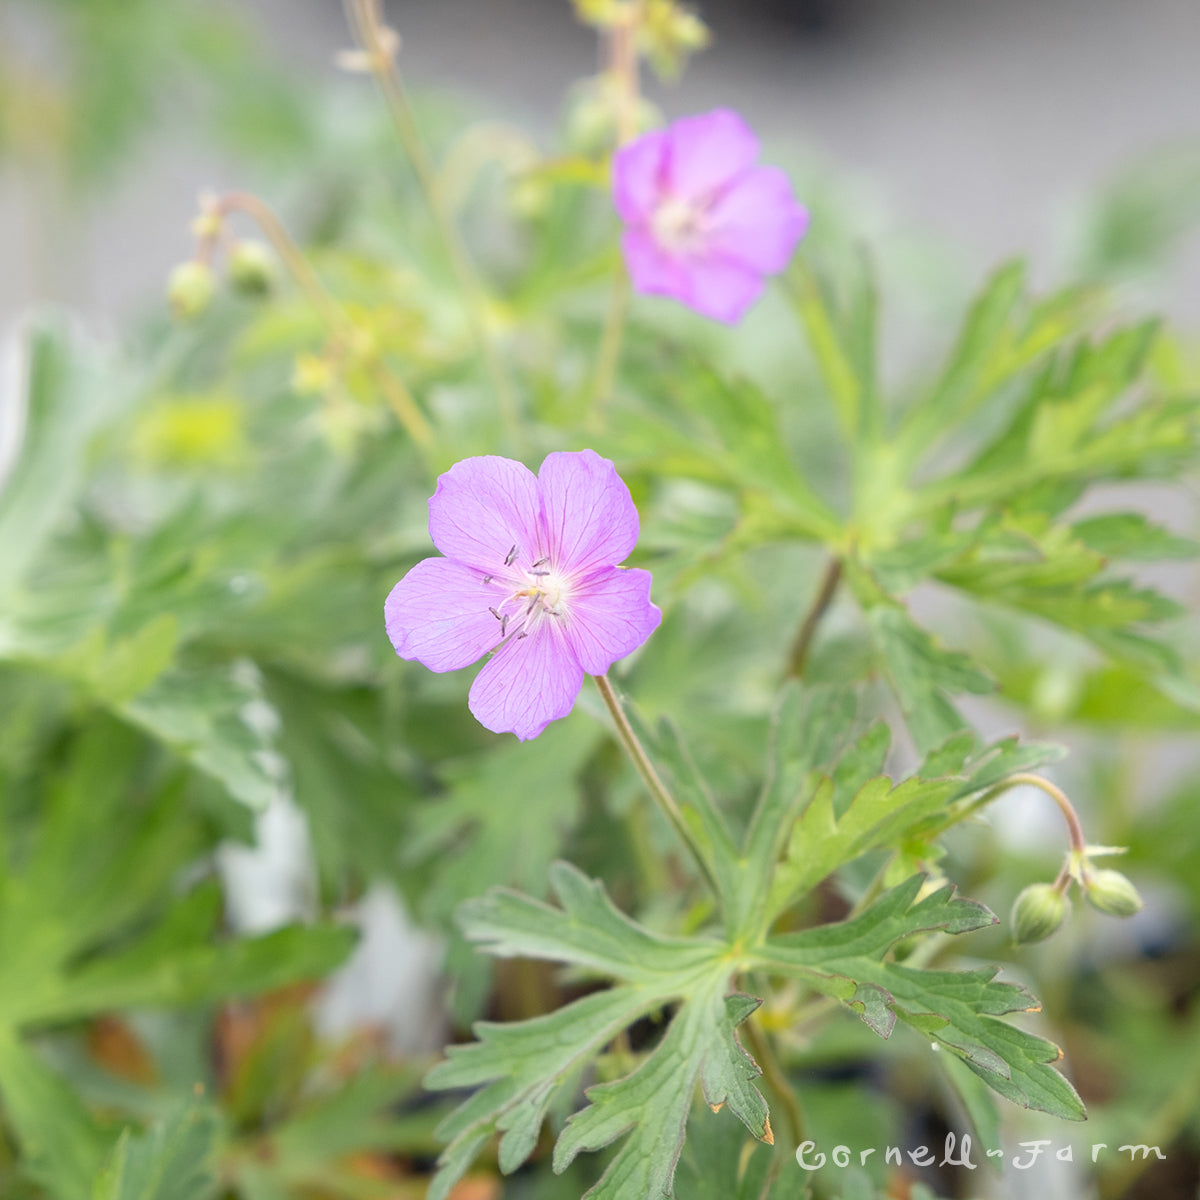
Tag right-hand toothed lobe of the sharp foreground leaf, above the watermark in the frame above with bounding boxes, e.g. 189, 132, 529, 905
758, 876, 1085, 1121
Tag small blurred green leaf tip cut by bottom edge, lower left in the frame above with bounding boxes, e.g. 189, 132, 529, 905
92, 1100, 220, 1200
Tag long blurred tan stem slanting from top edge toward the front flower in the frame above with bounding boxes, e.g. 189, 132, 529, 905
346, 0, 521, 440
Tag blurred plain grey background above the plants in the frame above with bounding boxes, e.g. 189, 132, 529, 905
0, 0, 1200, 326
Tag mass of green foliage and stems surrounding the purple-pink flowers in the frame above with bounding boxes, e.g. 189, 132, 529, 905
0, 5, 1200, 1198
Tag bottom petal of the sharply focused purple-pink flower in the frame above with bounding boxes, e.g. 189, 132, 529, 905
467, 622, 583, 742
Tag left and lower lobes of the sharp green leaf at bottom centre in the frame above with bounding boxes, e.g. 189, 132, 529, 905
426, 863, 769, 1200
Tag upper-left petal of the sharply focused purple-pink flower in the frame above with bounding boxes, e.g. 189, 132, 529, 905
430, 455, 544, 576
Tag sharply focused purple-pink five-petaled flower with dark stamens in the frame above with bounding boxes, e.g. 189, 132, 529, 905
384, 450, 662, 742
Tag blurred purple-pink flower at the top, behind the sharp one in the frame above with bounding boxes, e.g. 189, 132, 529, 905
613, 108, 809, 325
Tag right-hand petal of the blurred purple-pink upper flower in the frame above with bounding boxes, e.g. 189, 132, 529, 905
708, 167, 809, 275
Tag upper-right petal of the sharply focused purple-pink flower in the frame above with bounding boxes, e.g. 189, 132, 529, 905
538, 450, 638, 576
